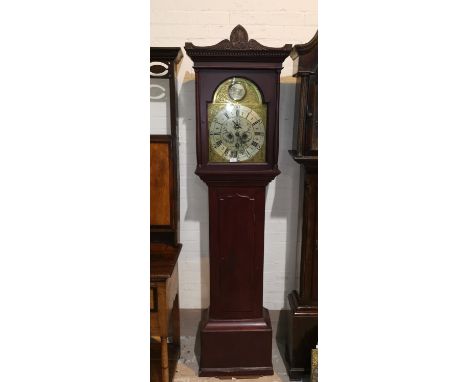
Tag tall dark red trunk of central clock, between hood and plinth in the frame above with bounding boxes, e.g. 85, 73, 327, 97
210, 186, 265, 319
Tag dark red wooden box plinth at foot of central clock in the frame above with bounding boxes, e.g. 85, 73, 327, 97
199, 308, 273, 377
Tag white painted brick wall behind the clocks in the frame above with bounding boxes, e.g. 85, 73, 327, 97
151, 0, 317, 309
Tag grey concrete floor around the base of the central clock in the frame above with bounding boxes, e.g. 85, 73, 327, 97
166, 309, 310, 382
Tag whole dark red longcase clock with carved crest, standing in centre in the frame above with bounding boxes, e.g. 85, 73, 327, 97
185, 25, 291, 377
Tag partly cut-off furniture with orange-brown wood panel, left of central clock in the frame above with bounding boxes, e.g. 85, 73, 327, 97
150, 47, 182, 382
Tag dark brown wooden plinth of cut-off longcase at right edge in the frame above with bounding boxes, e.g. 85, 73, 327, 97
286, 291, 318, 380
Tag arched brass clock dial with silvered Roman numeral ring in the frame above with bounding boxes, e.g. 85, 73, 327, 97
208, 78, 267, 163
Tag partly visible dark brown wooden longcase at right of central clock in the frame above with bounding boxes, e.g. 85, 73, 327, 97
286, 34, 318, 380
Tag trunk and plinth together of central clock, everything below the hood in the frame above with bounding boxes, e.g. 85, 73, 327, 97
195, 181, 273, 377
